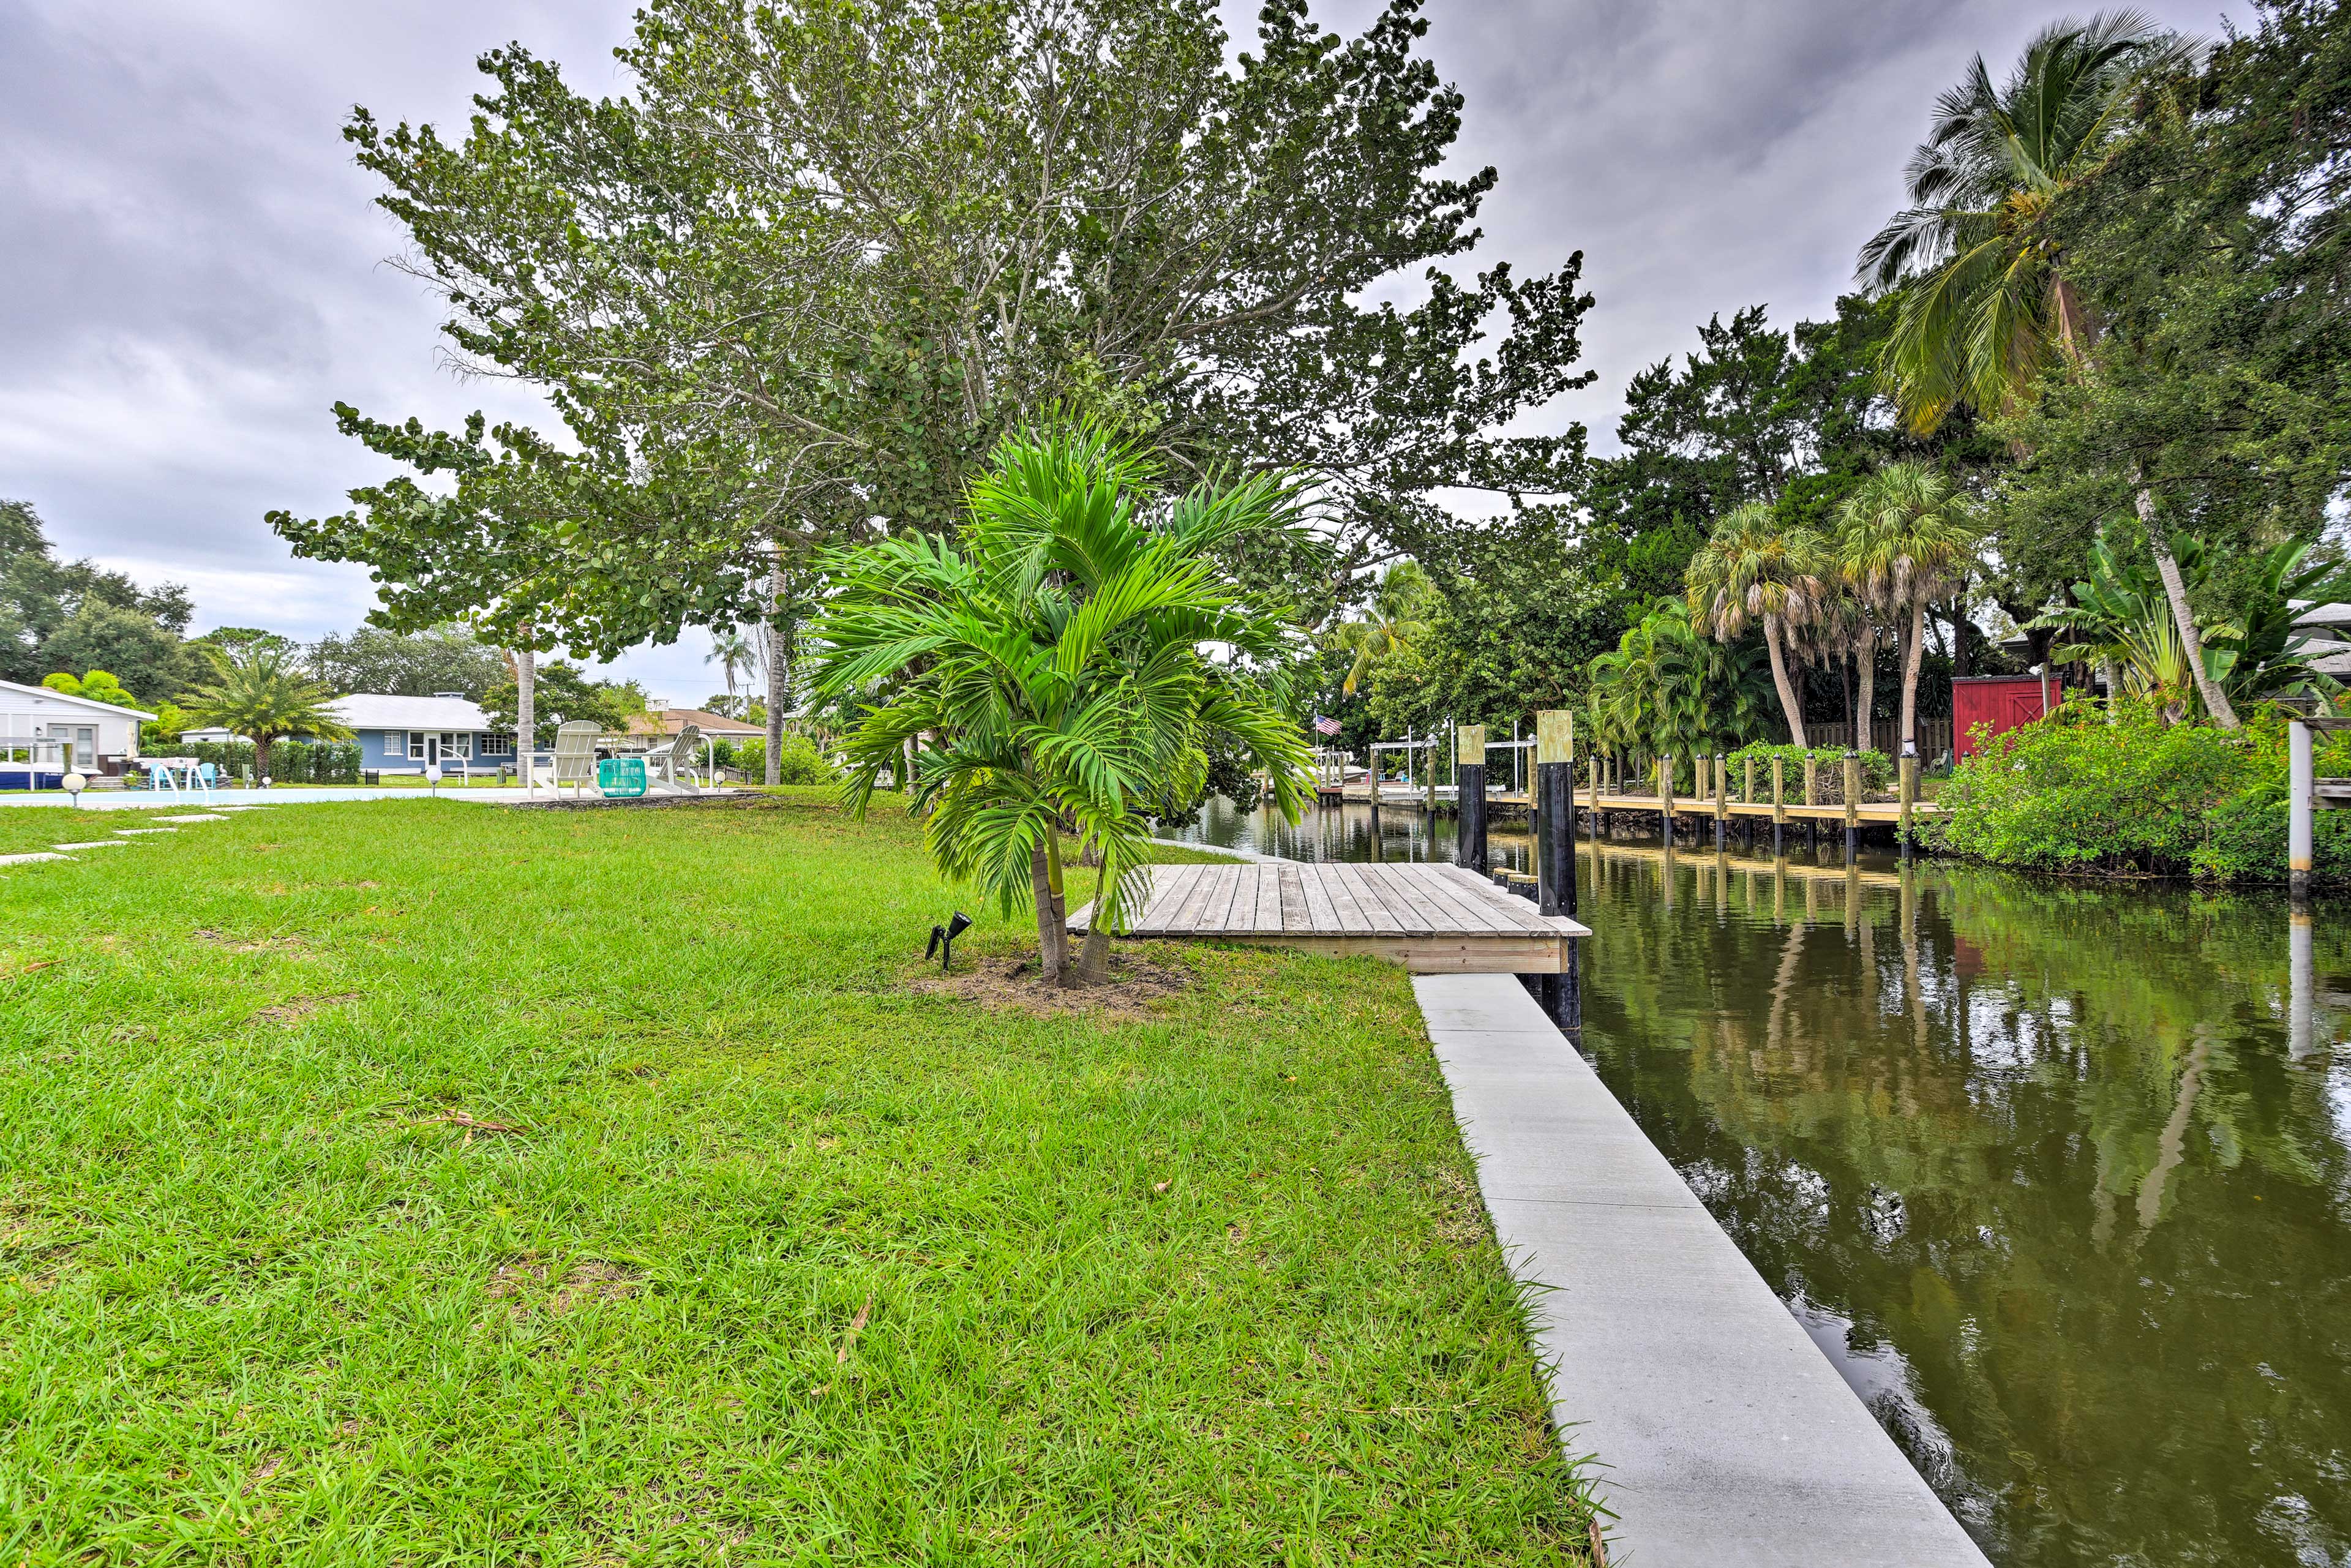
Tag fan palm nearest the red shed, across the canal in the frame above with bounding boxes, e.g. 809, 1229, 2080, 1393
1836, 463, 1982, 752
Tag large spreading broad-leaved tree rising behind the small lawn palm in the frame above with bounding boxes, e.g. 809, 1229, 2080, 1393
272, 0, 1592, 780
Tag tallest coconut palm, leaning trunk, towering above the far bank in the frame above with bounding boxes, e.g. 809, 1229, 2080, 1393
1858, 12, 2236, 729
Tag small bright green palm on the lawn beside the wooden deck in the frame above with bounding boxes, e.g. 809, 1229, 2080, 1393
814, 430, 1312, 983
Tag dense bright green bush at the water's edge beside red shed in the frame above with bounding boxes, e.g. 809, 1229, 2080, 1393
1925, 698, 2351, 882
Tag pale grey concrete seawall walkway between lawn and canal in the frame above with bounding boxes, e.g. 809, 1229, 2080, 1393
1413, 975, 1987, 1568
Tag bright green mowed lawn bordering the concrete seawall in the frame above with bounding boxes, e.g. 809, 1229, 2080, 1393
0, 792, 1587, 1566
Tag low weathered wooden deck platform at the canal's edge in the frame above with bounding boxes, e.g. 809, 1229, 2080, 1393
1070, 860, 1592, 975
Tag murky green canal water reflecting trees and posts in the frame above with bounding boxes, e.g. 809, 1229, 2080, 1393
1183, 801, 2351, 1568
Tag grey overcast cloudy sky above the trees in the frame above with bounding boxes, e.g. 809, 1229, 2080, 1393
0, 0, 2245, 703
